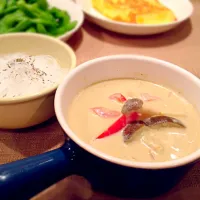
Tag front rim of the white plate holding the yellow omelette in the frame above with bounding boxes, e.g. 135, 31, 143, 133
79, 0, 194, 28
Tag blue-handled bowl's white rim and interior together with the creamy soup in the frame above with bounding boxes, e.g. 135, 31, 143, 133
55, 55, 200, 169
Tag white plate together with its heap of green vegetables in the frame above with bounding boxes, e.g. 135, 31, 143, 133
0, 0, 84, 41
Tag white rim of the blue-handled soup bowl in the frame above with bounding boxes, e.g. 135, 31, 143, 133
54, 54, 200, 170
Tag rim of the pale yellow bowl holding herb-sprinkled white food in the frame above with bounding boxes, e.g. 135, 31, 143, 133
0, 33, 76, 105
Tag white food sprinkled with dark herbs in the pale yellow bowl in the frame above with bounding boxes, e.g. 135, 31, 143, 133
0, 53, 63, 98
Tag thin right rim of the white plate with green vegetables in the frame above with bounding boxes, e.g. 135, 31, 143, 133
57, 0, 85, 40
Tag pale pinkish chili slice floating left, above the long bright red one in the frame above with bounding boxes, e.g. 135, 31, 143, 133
91, 107, 121, 118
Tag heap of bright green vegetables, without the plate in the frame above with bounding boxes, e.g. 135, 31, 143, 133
0, 0, 77, 37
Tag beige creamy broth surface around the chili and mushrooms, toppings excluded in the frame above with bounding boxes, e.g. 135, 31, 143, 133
66, 79, 200, 162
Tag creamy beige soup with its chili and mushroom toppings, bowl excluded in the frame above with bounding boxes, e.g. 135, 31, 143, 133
67, 79, 200, 162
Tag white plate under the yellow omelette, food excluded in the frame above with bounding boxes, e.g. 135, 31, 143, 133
75, 0, 193, 35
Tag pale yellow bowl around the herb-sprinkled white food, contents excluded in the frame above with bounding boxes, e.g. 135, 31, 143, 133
0, 33, 76, 129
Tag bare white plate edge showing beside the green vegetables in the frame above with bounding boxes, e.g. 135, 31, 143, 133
48, 0, 84, 41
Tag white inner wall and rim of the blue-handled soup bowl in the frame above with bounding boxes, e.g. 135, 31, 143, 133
55, 55, 200, 169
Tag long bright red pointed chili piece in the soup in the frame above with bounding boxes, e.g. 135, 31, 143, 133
97, 112, 139, 139
